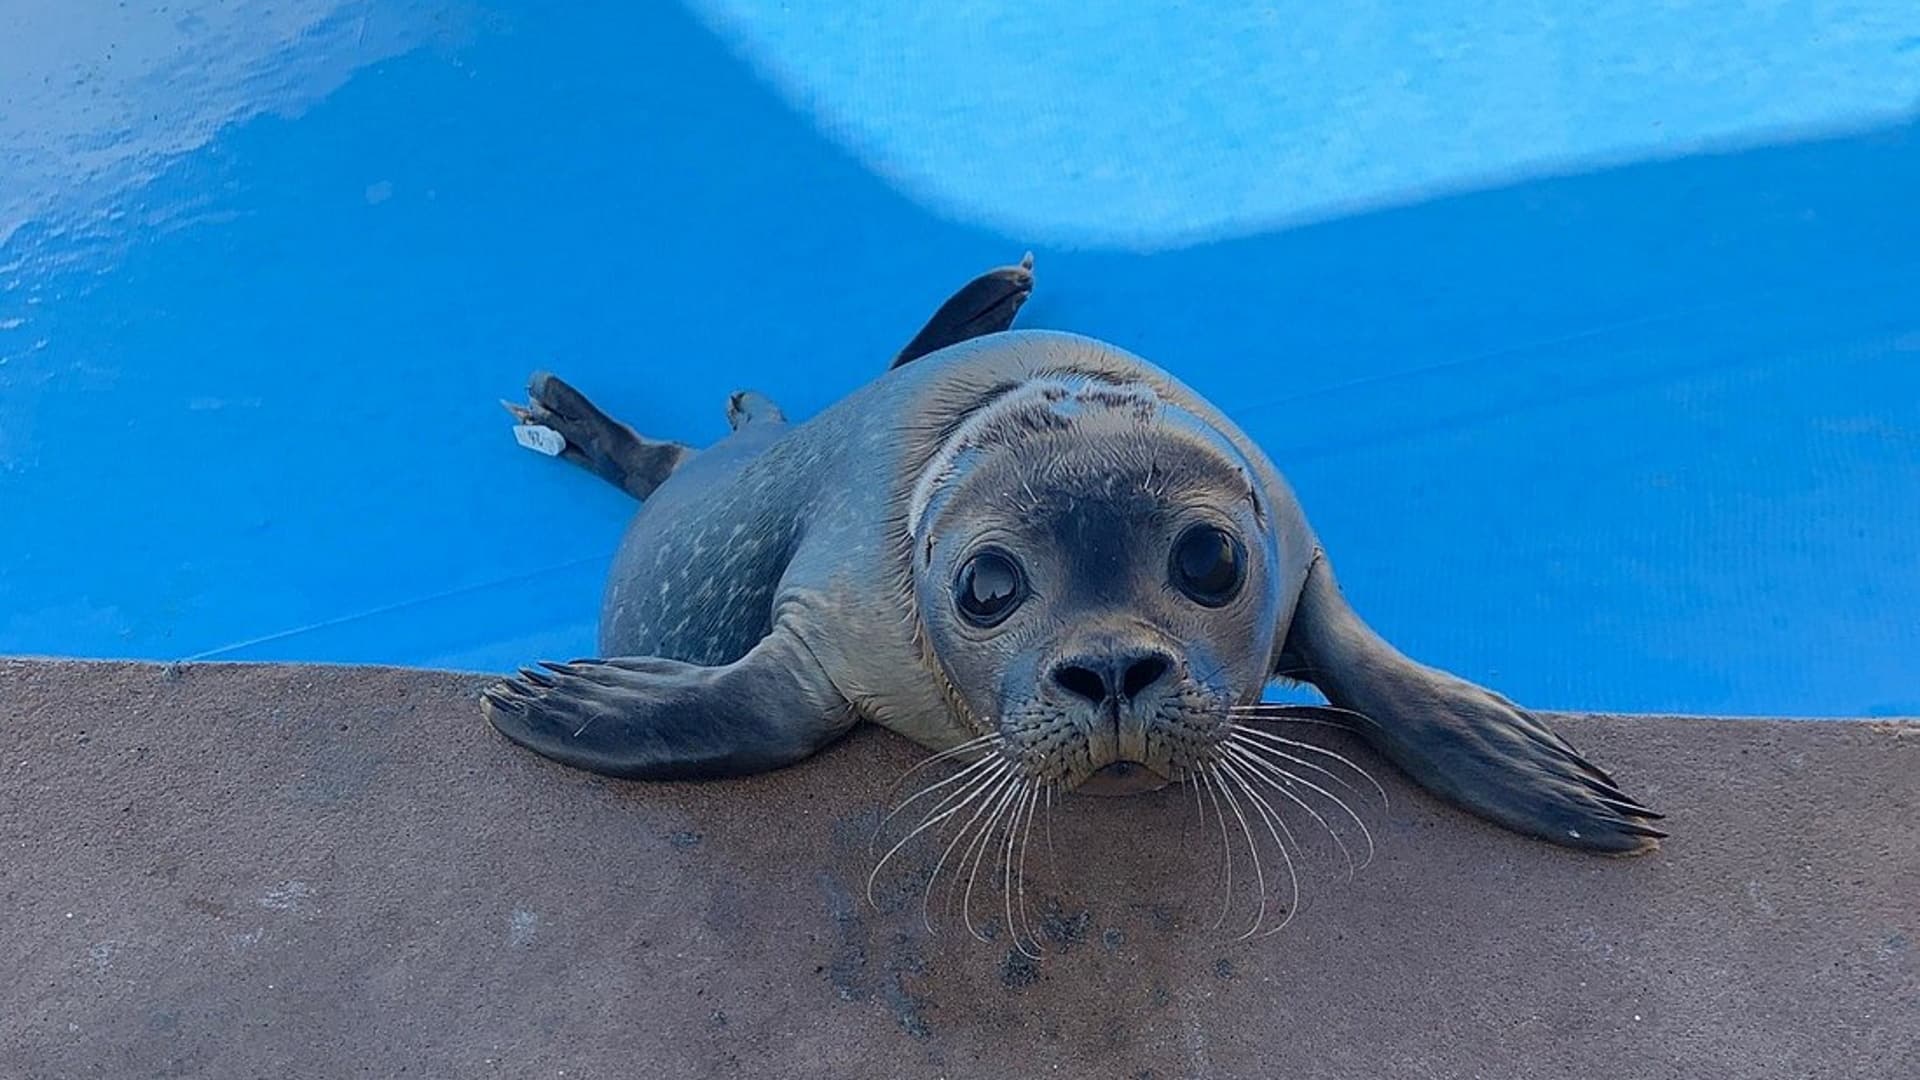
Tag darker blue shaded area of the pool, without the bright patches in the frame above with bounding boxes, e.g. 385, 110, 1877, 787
0, 6, 1920, 715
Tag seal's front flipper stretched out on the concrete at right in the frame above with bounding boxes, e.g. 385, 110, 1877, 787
1279, 557, 1667, 853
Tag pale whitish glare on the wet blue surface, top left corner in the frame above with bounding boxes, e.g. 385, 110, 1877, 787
0, 0, 476, 245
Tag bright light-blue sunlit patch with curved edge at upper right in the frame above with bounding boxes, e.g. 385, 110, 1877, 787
691, 0, 1920, 250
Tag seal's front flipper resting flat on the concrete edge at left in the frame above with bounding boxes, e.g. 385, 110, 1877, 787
482, 626, 854, 780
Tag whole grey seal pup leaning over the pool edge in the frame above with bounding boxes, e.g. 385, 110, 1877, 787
484, 256, 1665, 891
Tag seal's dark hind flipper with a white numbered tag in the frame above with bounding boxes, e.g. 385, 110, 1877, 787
503, 371, 693, 500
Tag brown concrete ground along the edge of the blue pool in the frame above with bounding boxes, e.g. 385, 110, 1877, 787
0, 661, 1920, 1080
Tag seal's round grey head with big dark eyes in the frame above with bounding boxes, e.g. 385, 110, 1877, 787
908, 365, 1283, 794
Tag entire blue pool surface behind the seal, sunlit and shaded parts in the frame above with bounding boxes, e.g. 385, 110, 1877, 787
0, 8, 1920, 717
